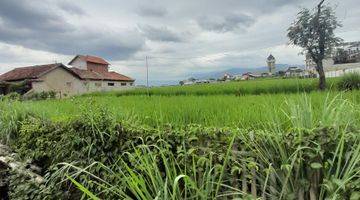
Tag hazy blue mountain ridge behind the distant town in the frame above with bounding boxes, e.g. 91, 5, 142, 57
189, 64, 303, 79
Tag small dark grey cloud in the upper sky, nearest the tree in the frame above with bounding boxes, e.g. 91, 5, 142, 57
197, 14, 255, 32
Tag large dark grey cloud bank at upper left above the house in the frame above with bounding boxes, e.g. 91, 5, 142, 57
0, 0, 144, 59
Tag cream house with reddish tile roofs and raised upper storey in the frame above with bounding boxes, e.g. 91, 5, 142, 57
0, 55, 135, 96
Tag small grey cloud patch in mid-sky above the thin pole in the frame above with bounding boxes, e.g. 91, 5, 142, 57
139, 25, 186, 42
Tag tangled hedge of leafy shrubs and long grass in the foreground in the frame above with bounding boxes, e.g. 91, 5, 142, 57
0, 92, 360, 200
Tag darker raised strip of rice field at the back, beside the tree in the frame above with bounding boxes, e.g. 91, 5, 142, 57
104, 78, 339, 96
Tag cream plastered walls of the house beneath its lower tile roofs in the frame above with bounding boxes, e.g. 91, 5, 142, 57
31, 67, 134, 97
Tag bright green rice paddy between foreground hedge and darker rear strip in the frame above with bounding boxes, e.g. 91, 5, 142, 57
18, 92, 360, 128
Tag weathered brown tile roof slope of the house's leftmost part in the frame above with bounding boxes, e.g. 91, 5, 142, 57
0, 63, 66, 81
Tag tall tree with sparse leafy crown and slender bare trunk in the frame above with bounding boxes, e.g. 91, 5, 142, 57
287, 0, 342, 90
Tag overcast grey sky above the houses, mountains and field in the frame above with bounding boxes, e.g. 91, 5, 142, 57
0, 0, 360, 84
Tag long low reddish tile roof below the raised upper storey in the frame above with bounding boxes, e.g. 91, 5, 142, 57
70, 67, 134, 82
